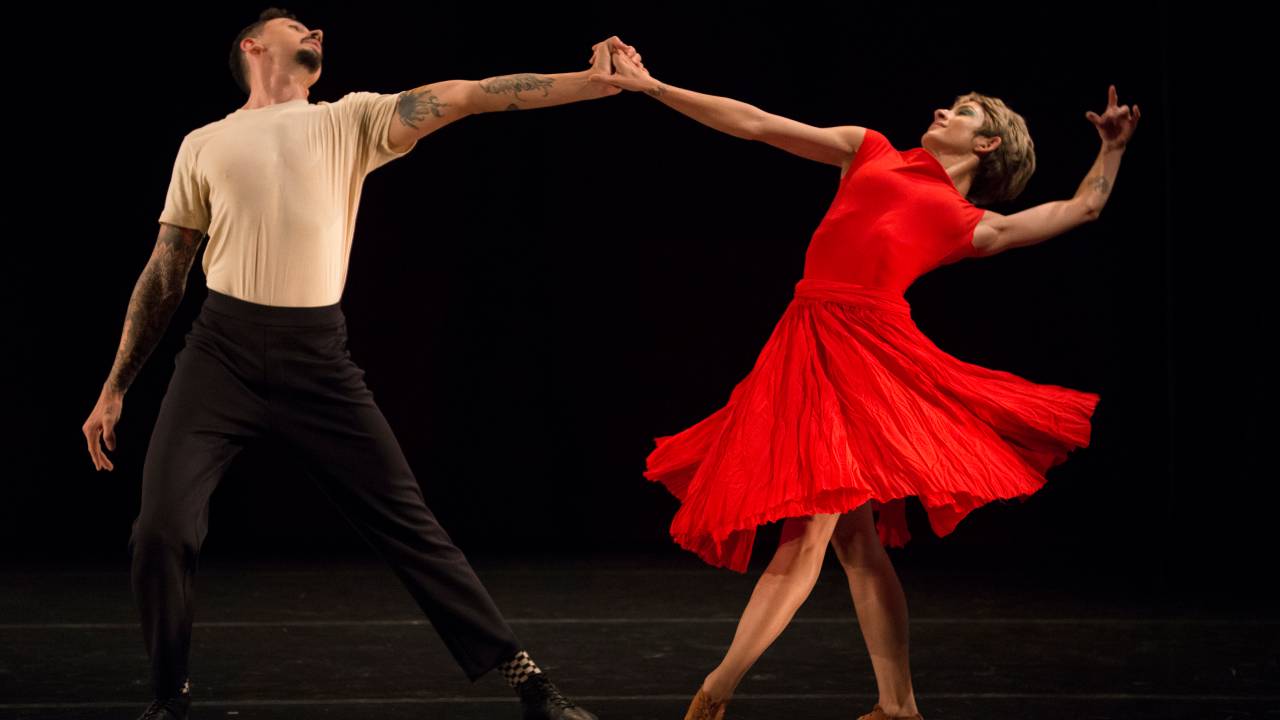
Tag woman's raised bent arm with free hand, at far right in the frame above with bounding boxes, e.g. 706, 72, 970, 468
973, 85, 1142, 255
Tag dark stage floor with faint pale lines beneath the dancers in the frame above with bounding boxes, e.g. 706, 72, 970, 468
0, 545, 1280, 720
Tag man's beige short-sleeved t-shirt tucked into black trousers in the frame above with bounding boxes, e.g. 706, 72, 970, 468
160, 92, 416, 307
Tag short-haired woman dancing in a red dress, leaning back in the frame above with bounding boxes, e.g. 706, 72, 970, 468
593, 47, 1139, 720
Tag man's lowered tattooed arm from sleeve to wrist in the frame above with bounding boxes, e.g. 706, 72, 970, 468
108, 224, 205, 393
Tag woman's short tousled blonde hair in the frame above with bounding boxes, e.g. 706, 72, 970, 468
951, 92, 1036, 205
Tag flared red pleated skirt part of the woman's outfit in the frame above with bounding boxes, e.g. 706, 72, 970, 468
645, 279, 1100, 573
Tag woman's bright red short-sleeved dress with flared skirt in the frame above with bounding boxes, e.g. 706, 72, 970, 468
645, 129, 1100, 573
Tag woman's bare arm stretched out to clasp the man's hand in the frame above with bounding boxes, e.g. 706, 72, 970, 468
591, 53, 867, 168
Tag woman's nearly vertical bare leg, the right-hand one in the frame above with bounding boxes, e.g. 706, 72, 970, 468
831, 502, 919, 715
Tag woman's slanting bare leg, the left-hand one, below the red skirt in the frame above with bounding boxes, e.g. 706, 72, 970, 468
703, 515, 840, 702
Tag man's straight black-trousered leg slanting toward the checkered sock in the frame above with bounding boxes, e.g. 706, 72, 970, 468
268, 322, 521, 682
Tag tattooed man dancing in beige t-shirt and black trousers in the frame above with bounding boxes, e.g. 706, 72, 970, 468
83, 8, 634, 720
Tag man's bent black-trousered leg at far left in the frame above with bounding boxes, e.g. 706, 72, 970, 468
129, 307, 265, 698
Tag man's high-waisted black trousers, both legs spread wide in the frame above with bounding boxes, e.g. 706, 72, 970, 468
129, 290, 520, 697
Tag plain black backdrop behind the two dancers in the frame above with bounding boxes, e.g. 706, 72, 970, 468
0, 3, 1275, 587
